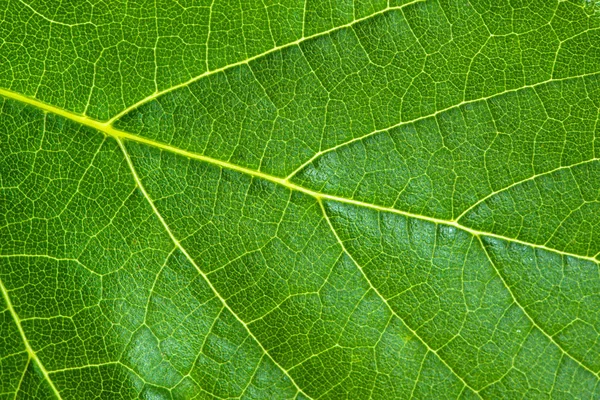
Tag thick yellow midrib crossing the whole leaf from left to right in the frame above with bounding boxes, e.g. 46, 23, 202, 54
0, 88, 600, 264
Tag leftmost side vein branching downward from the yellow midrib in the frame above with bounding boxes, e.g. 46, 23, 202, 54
116, 138, 311, 399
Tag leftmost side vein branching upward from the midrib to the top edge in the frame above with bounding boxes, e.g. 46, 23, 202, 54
107, 0, 425, 124
